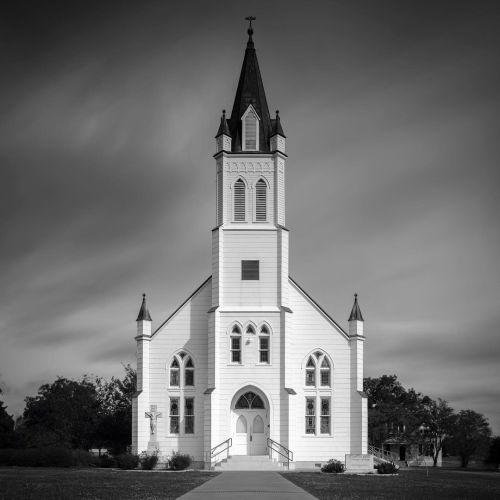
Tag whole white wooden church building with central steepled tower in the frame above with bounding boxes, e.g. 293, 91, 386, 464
132, 22, 368, 468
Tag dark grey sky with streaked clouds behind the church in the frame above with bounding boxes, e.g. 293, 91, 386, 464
0, 0, 500, 434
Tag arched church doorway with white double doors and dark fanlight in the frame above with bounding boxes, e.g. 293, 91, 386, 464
231, 388, 269, 455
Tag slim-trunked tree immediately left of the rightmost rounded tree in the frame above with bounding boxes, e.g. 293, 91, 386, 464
420, 398, 456, 467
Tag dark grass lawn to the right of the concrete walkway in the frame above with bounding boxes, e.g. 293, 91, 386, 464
282, 469, 500, 500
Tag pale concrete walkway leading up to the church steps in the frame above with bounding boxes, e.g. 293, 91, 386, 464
179, 471, 316, 500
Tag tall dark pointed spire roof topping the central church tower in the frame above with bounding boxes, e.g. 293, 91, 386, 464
229, 21, 272, 152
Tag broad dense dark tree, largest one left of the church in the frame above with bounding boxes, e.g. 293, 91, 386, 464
23, 377, 98, 449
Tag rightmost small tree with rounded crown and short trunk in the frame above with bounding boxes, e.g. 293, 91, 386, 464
451, 410, 491, 467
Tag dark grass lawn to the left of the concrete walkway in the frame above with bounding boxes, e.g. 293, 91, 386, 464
0, 467, 217, 500
